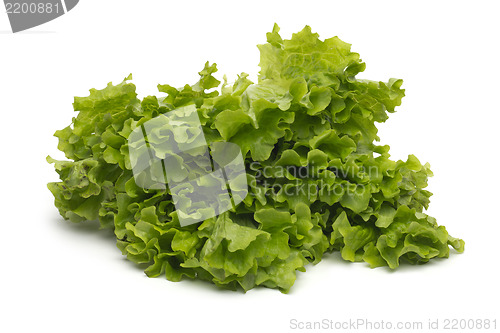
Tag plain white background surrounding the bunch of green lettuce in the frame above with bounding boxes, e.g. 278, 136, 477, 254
0, 0, 500, 332
